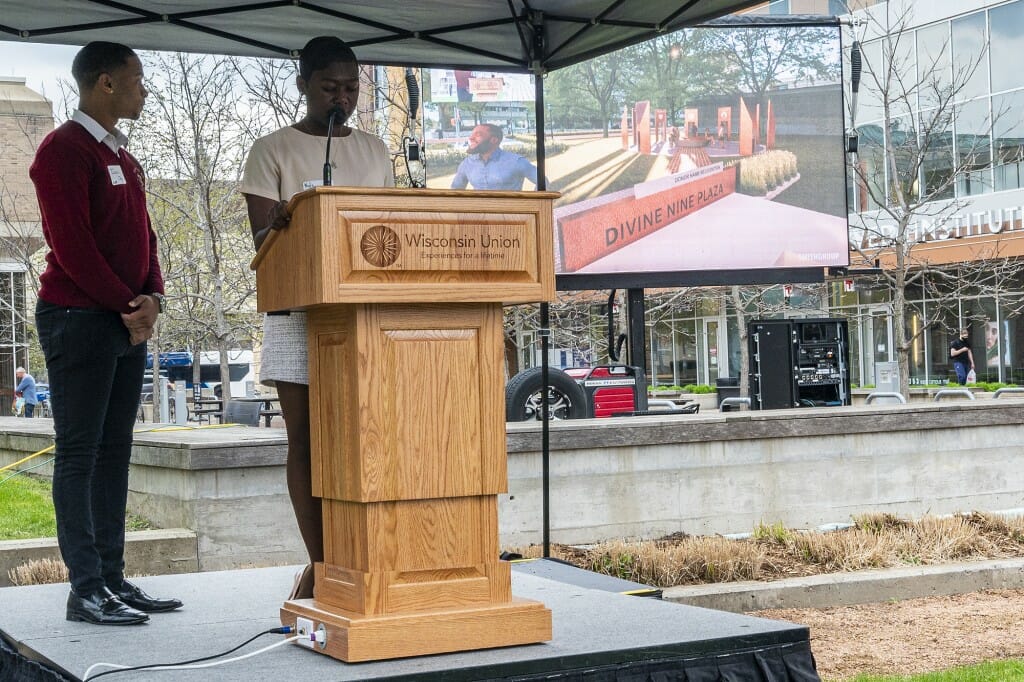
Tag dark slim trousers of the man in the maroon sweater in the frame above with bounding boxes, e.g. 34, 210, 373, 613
36, 299, 145, 594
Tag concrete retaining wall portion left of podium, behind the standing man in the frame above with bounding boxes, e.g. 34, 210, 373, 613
0, 418, 308, 570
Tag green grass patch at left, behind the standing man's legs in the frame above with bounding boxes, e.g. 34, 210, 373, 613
0, 476, 154, 540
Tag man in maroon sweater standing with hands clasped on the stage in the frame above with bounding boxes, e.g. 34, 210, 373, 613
29, 42, 181, 625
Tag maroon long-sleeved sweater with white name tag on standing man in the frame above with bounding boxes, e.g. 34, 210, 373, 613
29, 121, 164, 312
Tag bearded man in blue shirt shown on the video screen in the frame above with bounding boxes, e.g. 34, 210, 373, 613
452, 123, 537, 190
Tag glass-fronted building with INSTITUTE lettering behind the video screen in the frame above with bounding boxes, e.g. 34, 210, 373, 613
634, 0, 1024, 386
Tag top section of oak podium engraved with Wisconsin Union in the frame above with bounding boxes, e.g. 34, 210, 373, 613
251, 186, 560, 303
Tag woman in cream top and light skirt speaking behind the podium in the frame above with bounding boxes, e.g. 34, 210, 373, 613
242, 36, 394, 599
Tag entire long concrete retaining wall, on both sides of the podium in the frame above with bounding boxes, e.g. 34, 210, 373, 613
0, 398, 1024, 570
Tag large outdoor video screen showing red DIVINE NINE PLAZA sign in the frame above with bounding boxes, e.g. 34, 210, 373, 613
427, 21, 849, 289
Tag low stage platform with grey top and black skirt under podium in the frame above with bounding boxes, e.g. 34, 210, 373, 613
0, 560, 819, 682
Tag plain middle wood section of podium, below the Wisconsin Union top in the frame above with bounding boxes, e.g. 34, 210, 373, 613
308, 303, 507, 502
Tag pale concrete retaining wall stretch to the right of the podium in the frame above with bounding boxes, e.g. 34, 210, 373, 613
501, 398, 1024, 544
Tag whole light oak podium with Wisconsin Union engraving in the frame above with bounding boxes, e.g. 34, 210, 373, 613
253, 187, 558, 662
